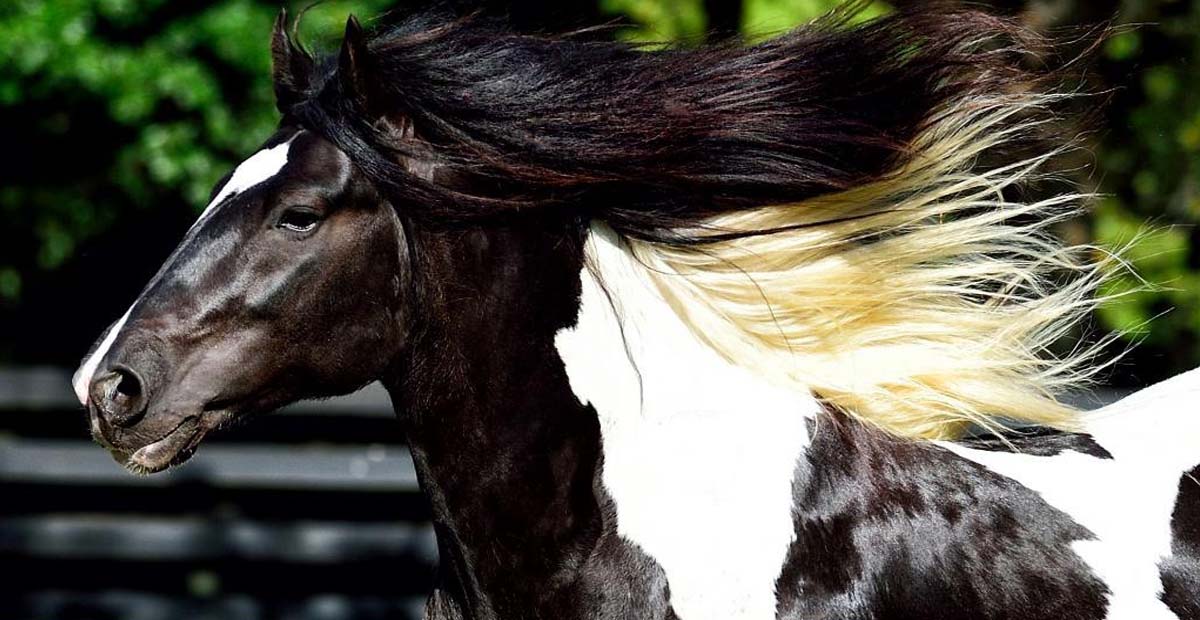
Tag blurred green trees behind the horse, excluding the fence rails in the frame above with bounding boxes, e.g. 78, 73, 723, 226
0, 0, 1200, 379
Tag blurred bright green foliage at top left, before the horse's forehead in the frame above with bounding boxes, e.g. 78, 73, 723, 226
0, 0, 389, 290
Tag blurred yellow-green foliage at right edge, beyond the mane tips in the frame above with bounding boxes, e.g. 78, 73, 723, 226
1093, 1, 1200, 363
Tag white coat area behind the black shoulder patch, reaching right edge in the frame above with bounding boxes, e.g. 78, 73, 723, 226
941, 371, 1200, 620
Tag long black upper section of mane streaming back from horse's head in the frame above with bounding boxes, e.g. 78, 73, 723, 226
277, 2, 1070, 242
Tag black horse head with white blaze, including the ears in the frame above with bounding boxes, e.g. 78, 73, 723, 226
73, 16, 409, 472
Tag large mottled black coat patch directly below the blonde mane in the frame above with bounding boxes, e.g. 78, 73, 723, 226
776, 415, 1108, 620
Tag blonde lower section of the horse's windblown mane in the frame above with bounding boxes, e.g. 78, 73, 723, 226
624, 94, 1124, 439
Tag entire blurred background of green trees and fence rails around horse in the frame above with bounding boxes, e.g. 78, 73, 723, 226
0, 0, 1200, 620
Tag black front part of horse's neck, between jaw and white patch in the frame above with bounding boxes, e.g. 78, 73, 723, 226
385, 218, 601, 618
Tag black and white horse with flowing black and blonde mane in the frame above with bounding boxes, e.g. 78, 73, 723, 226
73, 5, 1200, 620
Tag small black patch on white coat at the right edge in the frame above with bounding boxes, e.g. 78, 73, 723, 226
1159, 465, 1200, 620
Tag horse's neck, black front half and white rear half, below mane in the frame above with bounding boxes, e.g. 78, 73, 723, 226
388, 219, 818, 618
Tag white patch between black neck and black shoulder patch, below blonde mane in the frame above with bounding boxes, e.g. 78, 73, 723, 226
556, 227, 818, 620
